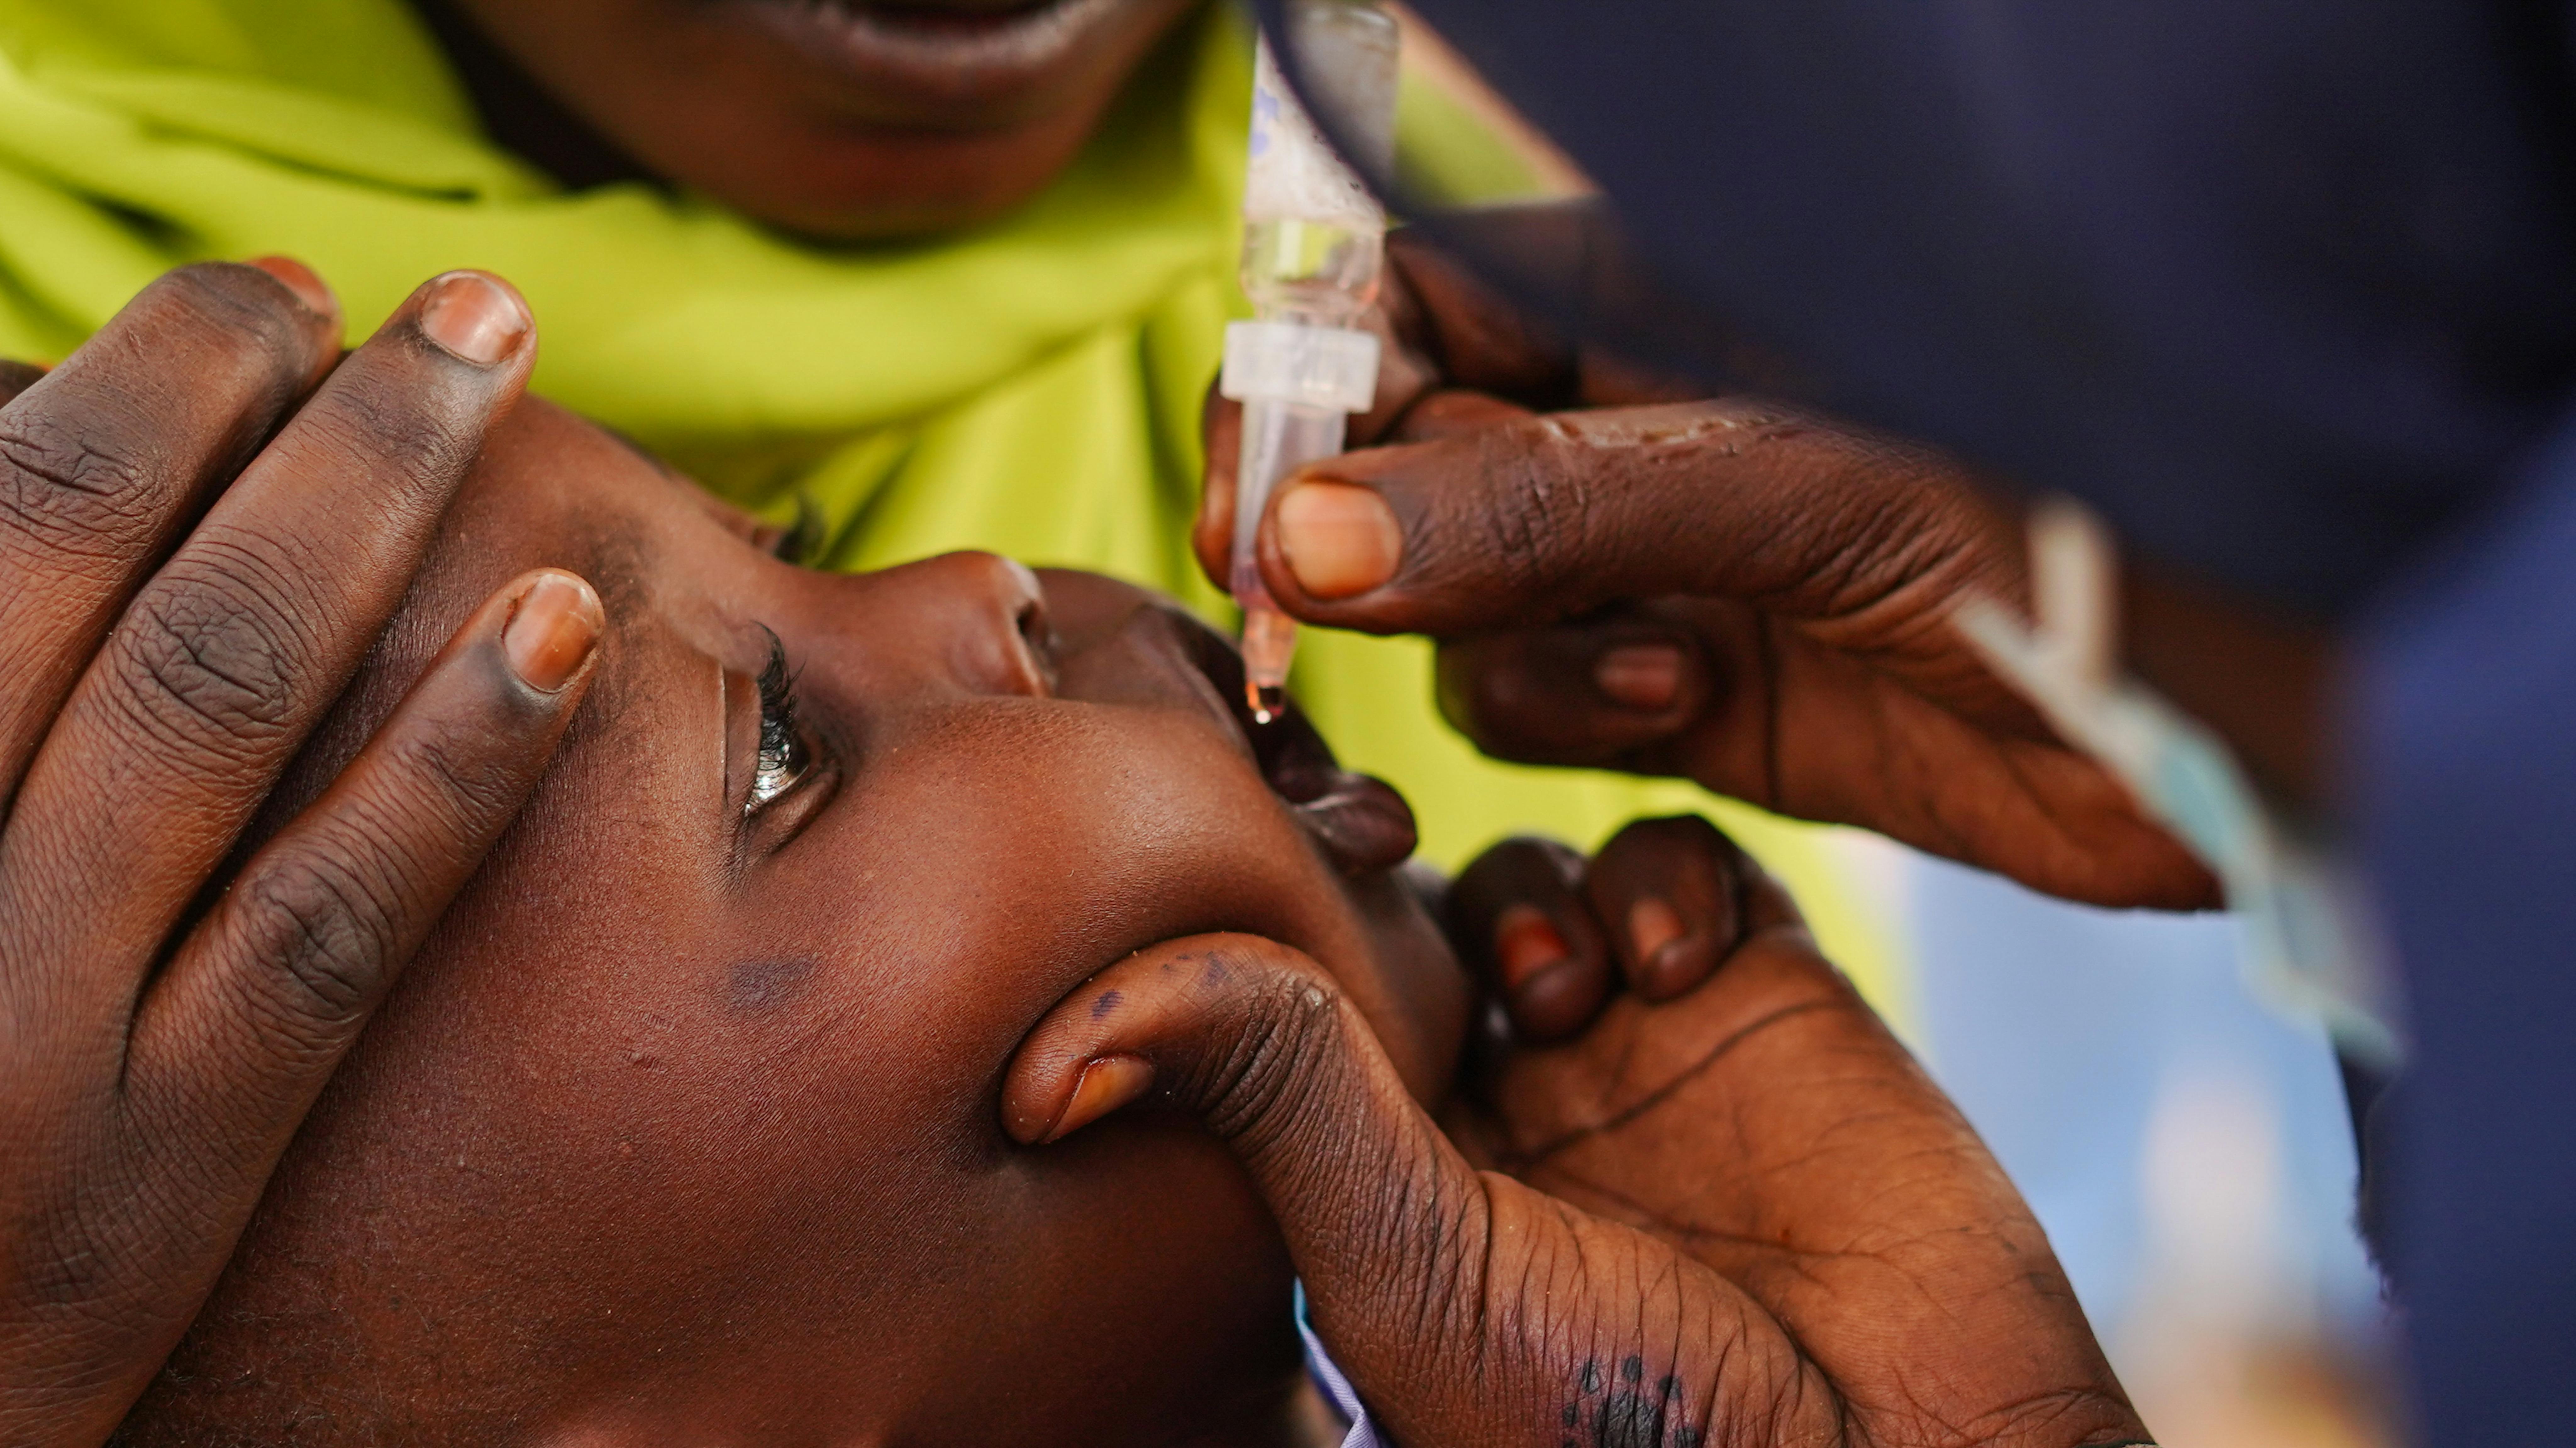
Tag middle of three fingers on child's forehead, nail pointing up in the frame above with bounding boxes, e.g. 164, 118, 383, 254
0, 273, 536, 1030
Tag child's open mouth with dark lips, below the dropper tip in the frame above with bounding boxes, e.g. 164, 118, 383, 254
1162, 608, 1414, 876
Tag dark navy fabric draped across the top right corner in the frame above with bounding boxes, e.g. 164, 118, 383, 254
1360, 0, 2576, 613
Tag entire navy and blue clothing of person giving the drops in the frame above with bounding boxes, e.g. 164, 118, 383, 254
1257, 0, 2576, 1448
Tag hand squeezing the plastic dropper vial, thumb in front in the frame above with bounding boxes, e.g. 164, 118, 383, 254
1195, 229, 2331, 917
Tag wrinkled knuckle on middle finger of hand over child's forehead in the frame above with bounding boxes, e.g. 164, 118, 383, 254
116, 536, 312, 760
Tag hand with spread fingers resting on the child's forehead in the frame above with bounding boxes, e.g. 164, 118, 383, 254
0, 260, 600, 1443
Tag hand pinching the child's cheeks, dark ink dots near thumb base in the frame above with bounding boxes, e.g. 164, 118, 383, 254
1002, 822, 2146, 1448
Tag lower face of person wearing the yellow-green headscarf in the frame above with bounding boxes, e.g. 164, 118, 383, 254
446, 0, 1195, 237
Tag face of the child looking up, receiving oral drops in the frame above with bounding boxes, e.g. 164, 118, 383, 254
136, 402, 1463, 1445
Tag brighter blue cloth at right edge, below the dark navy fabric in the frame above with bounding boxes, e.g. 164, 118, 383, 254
2360, 417, 2576, 1448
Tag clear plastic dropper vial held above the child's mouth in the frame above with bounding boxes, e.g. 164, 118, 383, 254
1219, 0, 1396, 724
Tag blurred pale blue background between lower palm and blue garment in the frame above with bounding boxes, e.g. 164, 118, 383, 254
1834, 832, 2401, 1448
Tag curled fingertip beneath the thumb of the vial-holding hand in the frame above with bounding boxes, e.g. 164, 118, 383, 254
1435, 608, 1721, 768
